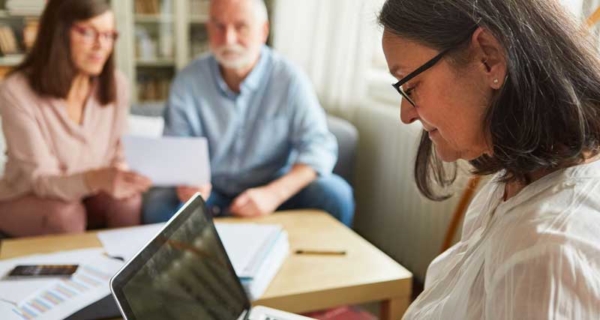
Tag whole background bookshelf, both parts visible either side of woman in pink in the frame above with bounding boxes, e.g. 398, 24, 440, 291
0, 0, 274, 103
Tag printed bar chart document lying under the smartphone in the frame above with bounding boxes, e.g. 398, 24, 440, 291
0, 249, 123, 320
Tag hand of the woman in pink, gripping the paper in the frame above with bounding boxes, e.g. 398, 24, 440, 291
85, 168, 152, 199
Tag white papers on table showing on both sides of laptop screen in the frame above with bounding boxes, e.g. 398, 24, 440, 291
98, 223, 289, 300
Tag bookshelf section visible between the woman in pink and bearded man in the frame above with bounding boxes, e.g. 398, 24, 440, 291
113, 0, 273, 103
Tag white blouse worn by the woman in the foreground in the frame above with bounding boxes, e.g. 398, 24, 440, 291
404, 161, 600, 320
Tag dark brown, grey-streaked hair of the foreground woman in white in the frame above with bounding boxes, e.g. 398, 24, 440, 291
379, 0, 600, 200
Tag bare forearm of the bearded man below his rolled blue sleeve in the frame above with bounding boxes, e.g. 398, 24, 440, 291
267, 164, 317, 203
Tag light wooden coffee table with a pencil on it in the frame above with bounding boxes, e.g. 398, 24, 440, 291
0, 211, 412, 320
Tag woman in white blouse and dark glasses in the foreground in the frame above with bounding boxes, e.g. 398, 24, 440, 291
379, 0, 600, 319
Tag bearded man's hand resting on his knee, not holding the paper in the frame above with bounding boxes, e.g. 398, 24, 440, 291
229, 187, 283, 218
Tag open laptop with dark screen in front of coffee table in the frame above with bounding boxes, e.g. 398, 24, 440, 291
110, 194, 310, 320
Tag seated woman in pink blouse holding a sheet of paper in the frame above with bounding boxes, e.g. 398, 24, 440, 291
0, 0, 151, 237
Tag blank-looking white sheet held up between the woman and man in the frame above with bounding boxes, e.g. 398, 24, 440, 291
122, 135, 210, 187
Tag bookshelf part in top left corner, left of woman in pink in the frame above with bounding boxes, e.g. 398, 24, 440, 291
0, 0, 45, 79
